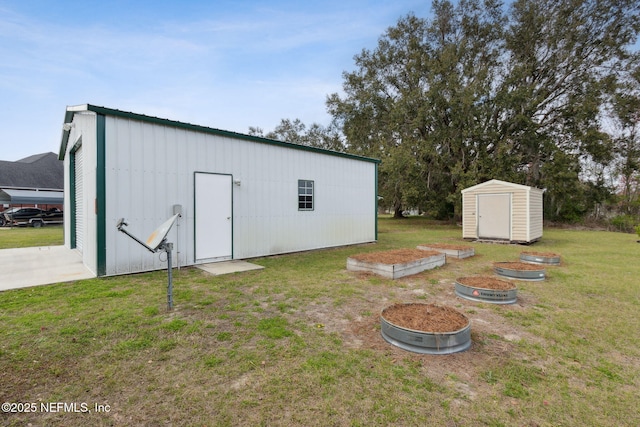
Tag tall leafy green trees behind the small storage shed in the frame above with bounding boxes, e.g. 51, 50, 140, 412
250, 0, 640, 227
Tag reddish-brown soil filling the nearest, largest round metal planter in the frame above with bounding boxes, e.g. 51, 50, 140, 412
382, 304, 469, 333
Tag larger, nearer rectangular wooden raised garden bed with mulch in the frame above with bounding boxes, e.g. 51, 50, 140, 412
347, 249, 445, 279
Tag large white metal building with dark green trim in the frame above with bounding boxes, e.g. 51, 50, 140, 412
59, 104, 379, 276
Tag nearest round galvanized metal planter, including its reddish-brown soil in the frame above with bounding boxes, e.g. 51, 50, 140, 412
380, 303, 471, 354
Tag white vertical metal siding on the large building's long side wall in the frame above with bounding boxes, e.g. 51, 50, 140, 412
106, 116, 376, 275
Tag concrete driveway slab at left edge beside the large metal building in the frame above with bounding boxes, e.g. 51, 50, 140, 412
0, 246, 96, 291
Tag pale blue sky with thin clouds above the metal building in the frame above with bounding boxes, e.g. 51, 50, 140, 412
0, 0, 431, 161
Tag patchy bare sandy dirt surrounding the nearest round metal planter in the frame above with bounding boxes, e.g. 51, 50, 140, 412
298, 254, 546, 407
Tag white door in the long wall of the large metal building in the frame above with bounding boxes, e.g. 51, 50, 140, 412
194, 172, 233, 262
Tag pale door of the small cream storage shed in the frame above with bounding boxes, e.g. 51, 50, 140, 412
478, 193, 511, 240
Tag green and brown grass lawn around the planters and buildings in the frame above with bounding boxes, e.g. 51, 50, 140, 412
0, 218, 640, 426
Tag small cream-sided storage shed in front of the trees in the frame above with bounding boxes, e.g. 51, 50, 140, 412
462, 179, 544, 244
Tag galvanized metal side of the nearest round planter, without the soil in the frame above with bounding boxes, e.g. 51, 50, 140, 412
380, 310, 471, 354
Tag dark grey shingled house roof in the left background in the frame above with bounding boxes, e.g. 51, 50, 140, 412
0, 152, 64, 190
